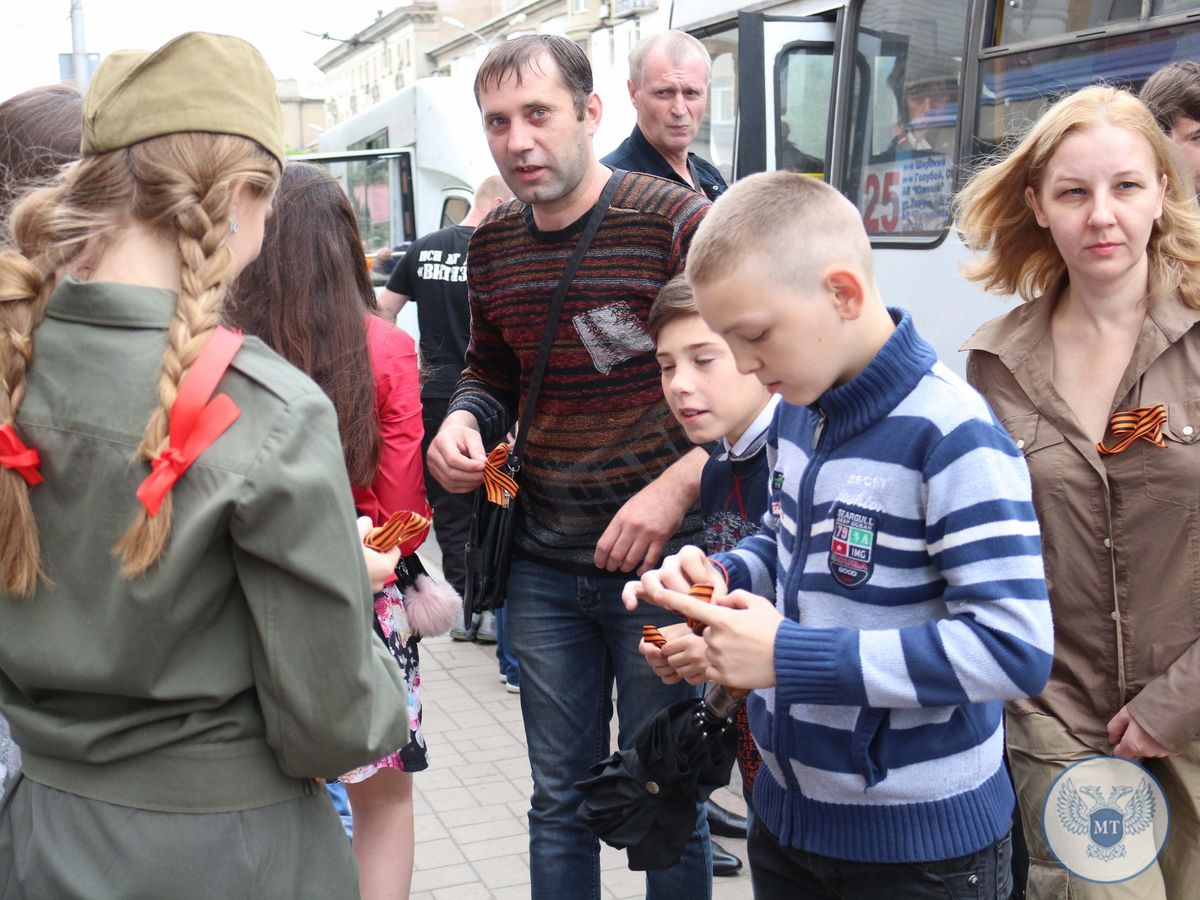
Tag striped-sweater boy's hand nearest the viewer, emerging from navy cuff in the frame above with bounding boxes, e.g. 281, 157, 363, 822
654, 588, 784, 690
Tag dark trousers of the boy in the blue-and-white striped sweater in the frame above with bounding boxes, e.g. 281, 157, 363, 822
748, 818, 1013, 900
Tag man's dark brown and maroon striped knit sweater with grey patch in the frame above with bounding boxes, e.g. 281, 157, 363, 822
450, 173, 709, 574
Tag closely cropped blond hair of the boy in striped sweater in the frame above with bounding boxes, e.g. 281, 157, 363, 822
688, 172, 875, 288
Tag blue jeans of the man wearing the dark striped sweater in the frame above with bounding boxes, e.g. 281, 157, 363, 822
508, 559, 713, 900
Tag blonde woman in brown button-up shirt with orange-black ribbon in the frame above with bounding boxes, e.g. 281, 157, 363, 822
958, 86, 1200, 898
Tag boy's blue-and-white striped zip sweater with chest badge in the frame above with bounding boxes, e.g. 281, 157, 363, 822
716, 311, 1054, 863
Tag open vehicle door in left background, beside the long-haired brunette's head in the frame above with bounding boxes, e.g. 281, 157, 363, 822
288, 150, 416, 259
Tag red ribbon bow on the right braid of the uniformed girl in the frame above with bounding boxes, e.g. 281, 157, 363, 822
138, 328, 242, 516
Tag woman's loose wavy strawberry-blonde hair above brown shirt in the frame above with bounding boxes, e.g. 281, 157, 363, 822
954, 85, 1200, 308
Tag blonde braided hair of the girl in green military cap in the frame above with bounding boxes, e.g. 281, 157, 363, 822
0, 133, 280, 596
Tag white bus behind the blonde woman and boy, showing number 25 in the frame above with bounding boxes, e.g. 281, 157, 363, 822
671, 0, 1200, 371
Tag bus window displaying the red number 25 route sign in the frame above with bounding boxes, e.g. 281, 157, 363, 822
840, 0, 967, 239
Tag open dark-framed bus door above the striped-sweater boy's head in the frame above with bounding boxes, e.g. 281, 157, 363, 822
729, 12, 839, 179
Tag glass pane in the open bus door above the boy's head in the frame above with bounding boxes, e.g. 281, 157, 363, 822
775, 43, 833, 180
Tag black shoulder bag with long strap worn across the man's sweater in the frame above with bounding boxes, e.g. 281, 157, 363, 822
462, 169, 625, 623
